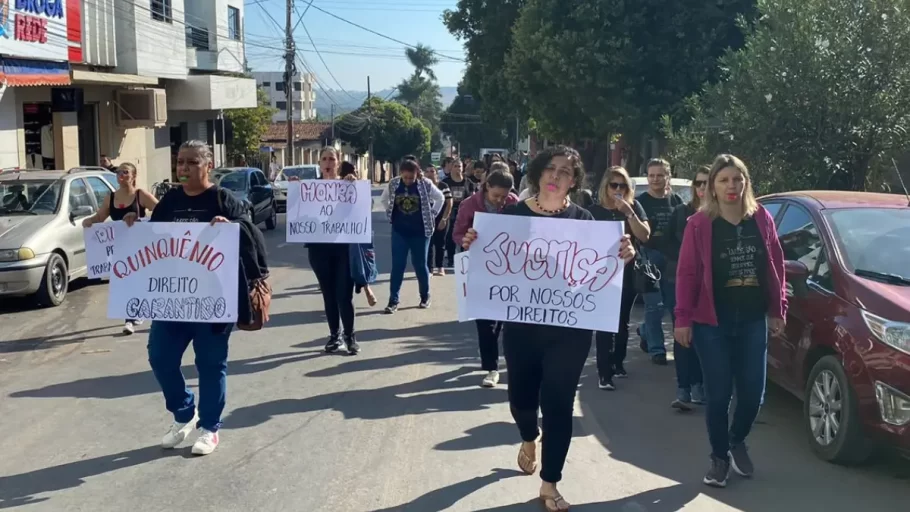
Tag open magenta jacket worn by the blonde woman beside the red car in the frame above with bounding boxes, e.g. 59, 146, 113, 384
675, 206, 787, 327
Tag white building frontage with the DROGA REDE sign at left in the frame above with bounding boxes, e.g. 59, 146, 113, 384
0, 0, 256, 188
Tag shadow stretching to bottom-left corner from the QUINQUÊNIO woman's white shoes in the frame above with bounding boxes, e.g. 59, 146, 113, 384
0, 446, 192, 509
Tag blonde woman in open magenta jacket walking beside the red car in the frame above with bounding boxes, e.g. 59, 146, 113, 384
675, 155, 787, 487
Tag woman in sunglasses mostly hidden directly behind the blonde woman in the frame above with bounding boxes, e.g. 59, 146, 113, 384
666, 165, 711, 411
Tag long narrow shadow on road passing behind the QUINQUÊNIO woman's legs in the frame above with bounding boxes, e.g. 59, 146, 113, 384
9, 351, 321, 400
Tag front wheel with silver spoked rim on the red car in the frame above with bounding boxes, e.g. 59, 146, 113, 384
803, 356, 872, 464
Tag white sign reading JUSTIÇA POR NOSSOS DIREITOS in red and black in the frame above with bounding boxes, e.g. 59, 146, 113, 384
467, 213, 625, 332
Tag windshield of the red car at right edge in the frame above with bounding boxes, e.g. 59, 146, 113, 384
827, 208, 910, 279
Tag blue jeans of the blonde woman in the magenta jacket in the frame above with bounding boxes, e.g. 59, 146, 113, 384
692, 318, 768, 460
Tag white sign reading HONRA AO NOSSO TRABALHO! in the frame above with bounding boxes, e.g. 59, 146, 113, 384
286, 180, 373, 244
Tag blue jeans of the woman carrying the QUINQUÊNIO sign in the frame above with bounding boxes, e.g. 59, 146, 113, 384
148, 320, 231, 432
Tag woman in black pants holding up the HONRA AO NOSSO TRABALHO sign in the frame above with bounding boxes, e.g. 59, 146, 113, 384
306, 146, 362, 355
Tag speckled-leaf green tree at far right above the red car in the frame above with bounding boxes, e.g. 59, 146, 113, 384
670, 0, 910, 192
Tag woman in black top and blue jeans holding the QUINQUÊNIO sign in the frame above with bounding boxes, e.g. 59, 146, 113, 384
123, 141, 268, 455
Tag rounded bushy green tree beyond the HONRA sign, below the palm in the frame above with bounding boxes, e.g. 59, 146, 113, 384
338, 97, 430, 162
